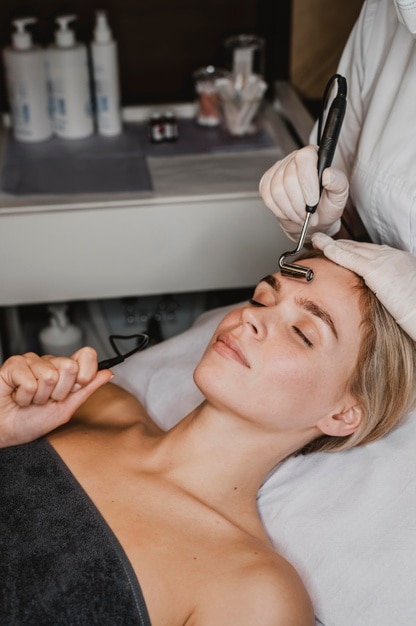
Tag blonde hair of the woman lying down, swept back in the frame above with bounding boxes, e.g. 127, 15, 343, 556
302, 254, 416, 454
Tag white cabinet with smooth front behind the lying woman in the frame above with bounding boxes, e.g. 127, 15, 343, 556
0, 83, 310, 306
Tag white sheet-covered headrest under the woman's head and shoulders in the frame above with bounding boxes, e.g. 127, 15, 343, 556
114, 307, 416, 626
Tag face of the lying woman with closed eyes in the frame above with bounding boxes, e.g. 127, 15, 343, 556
195, 258, 362, 430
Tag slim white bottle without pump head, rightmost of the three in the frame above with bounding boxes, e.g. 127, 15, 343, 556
91, 11, 122, 136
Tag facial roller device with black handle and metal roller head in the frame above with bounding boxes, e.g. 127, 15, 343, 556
279, 74, 347, 281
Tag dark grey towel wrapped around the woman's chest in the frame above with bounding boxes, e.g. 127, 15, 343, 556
0, 439, 151, 626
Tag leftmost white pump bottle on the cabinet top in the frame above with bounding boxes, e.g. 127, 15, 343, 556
3, 17, 52, 141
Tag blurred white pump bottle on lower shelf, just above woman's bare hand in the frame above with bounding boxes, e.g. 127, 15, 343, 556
39, 303, 82, 356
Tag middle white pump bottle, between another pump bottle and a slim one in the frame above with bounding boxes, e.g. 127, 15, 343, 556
47, 15, 94, 139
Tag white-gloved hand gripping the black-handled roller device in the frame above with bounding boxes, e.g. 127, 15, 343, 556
259, 146, 349, 241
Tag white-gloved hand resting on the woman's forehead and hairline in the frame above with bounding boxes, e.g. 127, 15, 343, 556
312, 233, 416, 341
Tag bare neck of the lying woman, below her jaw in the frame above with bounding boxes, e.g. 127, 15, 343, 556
149, 402, 315, 518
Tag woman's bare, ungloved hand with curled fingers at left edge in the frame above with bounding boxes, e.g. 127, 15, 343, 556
0, 348, 112, 447
